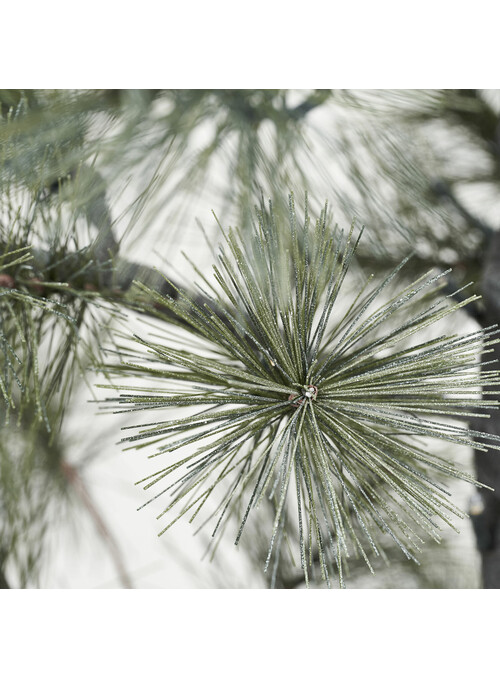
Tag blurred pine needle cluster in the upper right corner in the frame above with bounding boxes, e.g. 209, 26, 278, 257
323, 90, 500, 284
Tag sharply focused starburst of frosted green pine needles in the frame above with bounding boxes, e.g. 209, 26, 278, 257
99, 196, 500, 586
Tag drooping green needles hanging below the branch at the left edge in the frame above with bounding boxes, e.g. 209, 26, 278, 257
0, 222, 77, 587
